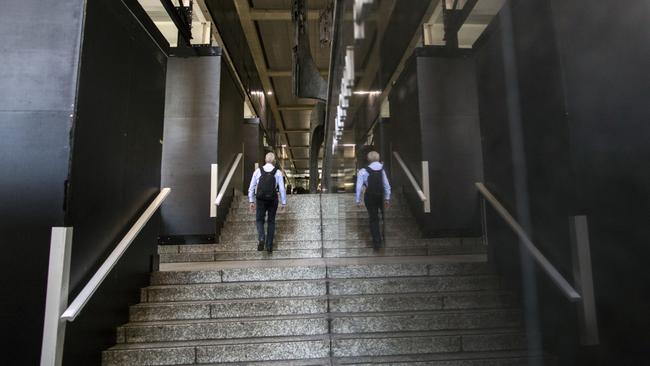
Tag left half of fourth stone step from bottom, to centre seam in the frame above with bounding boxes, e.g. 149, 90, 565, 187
141, 280, 326, 302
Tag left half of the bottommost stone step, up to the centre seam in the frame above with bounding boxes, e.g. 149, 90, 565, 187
102, 336, 330, 366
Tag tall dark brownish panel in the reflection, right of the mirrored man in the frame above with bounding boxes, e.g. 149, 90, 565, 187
416, 47, 483, 236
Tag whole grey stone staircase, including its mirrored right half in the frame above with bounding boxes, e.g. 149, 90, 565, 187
103, 195, 531, 366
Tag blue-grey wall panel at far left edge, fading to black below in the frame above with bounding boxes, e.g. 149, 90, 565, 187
0, 0, 84, 366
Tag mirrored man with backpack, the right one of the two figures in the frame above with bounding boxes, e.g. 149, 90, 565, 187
356, 151, 391, 250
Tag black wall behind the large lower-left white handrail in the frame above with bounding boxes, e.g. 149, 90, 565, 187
64, 1, 167, 365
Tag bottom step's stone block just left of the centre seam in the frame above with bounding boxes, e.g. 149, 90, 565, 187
196, 339, 329, 363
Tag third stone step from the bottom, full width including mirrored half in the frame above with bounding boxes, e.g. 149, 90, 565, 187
129, 291, 520, 322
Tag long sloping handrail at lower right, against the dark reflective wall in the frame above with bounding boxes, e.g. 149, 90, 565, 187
475, 182, 582, 302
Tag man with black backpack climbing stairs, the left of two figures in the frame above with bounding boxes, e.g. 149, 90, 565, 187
248, 152, 287, 253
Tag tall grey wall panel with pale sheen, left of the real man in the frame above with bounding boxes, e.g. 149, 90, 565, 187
161, 56, 221, 235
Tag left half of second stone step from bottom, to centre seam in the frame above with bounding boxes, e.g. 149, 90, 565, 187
117, 314, 328, 343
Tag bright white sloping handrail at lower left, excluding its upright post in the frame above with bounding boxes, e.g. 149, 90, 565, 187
61, 188, 171, 321
